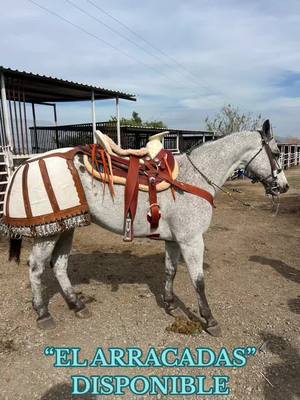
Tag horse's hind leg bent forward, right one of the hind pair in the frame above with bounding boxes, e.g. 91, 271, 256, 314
51, 230, 90, 318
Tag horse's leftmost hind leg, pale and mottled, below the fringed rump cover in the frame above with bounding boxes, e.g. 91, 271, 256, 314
28, 235, 59, 329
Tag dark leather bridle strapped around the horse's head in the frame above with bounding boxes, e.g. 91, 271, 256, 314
244, 130, 282, 194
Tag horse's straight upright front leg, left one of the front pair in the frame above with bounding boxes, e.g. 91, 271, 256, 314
164, 241, 180, 313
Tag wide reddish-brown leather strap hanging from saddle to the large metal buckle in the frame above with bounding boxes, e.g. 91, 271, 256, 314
124, 156, 139, 236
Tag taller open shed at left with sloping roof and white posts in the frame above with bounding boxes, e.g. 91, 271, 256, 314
0, 66, 136, 215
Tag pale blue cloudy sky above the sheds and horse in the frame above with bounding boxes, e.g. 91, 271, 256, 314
0, 0, 300, 136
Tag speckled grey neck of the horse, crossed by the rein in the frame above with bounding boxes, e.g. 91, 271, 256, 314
182, 132, 259, 186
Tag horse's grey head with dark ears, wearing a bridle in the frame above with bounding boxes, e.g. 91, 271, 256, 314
245, 119, 289, 196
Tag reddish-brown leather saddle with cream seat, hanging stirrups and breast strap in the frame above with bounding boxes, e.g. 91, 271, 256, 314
79, 131, 213, 241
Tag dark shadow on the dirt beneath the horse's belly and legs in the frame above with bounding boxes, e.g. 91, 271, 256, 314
43, 250, 209, 319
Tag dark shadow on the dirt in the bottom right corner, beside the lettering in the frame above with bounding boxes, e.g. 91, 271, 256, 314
260, 332, 300, 400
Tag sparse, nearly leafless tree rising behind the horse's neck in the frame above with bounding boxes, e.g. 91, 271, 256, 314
205, 104, 262, 135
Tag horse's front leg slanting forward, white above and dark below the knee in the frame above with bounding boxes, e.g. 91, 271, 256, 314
180, 235, 221, 336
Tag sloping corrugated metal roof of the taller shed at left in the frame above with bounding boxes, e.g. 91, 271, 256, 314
0, 66, 136, 103
